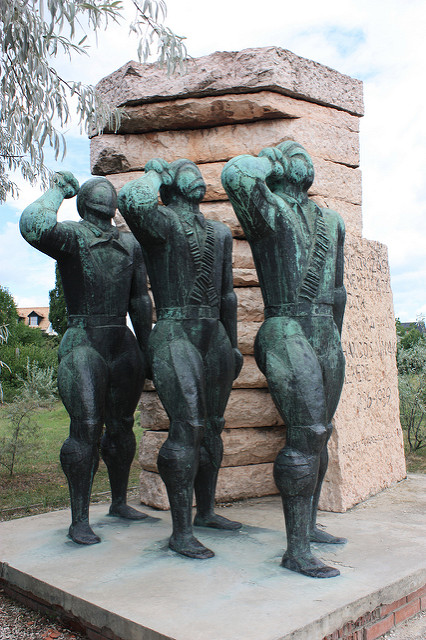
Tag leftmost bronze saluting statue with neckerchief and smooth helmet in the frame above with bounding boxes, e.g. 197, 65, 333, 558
20, 172, 152, 544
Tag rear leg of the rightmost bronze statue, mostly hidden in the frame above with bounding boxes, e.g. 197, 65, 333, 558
310, 323, 347, 544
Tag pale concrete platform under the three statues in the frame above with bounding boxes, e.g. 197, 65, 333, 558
0, 475, 426, 640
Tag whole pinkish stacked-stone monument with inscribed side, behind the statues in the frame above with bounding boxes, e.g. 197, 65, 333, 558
91, 47, 405, 511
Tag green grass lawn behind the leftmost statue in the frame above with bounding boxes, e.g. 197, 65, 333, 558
0, 402, 142, 521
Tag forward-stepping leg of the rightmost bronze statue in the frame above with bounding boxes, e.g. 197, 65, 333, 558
256, 318, 339, 578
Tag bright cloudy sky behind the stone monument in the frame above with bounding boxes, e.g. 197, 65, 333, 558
0, 0, 426, 322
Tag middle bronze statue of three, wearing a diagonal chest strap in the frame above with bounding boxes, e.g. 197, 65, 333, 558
118, 159, 242, 558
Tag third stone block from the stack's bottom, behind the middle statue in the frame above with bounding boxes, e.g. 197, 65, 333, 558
140, 389, 283, 431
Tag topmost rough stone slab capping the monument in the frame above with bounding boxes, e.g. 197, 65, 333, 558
97, 47, 364, 115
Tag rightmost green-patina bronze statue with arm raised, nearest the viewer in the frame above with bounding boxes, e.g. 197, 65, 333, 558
222, 141, 346, 578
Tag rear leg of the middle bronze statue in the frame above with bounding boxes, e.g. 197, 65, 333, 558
194, 323, 241, 531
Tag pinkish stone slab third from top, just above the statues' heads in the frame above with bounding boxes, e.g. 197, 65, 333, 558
90, 118, 359, 175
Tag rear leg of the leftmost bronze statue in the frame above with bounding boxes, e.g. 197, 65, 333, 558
101, 331, 147, 520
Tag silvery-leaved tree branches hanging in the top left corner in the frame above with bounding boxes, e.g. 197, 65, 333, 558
0, 0, 186, 202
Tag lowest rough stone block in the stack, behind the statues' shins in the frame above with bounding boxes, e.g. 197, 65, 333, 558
140, 462, 278, 509
